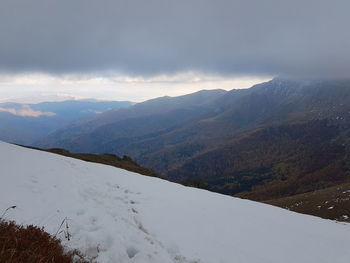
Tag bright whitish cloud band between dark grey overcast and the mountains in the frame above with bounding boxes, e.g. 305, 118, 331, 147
0, 72, 271, 102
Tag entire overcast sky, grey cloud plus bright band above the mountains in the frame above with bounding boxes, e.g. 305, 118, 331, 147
0, 0, 350, 101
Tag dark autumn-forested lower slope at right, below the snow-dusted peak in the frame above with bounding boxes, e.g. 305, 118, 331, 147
168, 120, 350, 196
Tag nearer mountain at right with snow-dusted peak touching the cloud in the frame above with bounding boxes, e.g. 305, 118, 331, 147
167, 79, 350, 197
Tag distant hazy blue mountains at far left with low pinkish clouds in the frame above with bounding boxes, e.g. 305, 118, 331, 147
0, 100, 132, 145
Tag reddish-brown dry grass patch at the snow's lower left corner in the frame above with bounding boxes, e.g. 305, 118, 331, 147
0, 220, 87, 263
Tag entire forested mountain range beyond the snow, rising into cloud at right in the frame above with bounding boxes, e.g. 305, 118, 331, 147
35, 78, 350, 200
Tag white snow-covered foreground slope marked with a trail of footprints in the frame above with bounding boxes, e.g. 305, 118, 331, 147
0, 142, 350, 263
